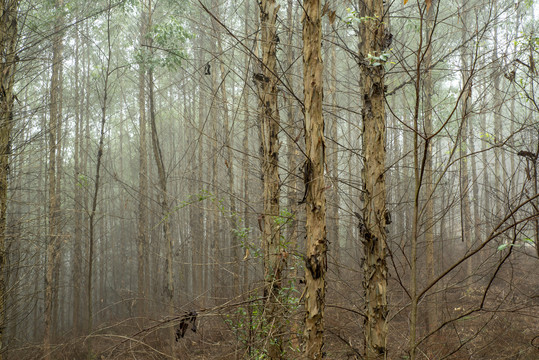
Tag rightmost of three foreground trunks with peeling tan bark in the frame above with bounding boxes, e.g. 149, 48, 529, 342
359, 0, 389, 360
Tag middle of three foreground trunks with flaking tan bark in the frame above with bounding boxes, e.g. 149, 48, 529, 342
302, 0, 327, 359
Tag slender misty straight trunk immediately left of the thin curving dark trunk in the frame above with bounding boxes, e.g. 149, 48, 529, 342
137, 2, 149, 316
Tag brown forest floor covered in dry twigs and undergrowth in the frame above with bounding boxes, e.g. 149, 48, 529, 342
6, 258, 539, 360
